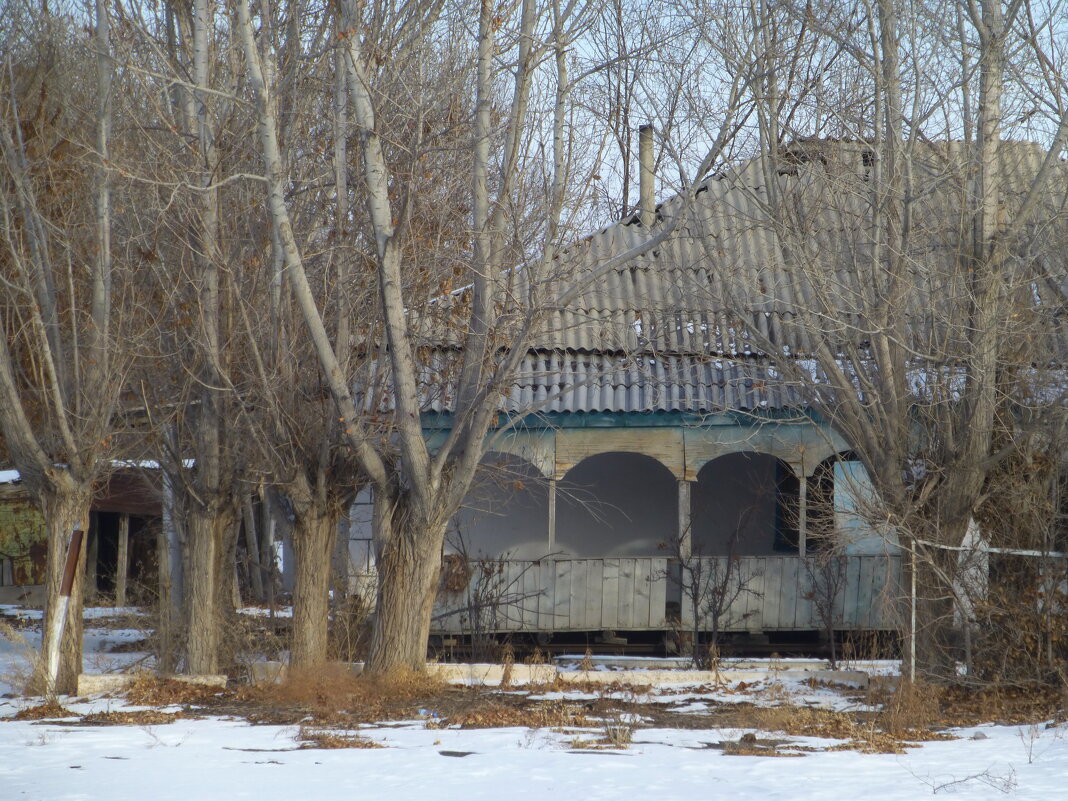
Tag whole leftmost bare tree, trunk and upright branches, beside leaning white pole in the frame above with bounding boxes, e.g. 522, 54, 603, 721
0, 2, 125, 692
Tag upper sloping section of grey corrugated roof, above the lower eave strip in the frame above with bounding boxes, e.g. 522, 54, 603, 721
533, 142, 1068, 356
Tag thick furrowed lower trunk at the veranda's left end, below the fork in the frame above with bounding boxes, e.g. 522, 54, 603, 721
366, 510, 445, 675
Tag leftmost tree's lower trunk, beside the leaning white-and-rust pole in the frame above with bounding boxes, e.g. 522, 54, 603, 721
33, 488, 89, 694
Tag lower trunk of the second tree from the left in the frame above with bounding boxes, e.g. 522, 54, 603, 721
186, 503, 234, 675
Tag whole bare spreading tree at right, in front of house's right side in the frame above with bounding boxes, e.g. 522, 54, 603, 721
674, 0, 1068, 674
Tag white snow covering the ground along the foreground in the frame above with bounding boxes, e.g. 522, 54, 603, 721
0, 610, 1068, 801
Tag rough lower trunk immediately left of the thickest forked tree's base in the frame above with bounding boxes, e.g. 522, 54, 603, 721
289, 509, 337, 668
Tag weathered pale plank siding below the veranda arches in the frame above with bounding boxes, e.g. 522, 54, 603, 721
431, 555, 901, 634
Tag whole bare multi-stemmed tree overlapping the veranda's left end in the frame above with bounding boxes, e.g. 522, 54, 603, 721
232, 0, 619, 671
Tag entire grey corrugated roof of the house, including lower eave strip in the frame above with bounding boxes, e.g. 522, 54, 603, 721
410, 142, 1068, 412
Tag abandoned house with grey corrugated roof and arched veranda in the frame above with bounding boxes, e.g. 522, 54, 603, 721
350, 142, 1063, 642
